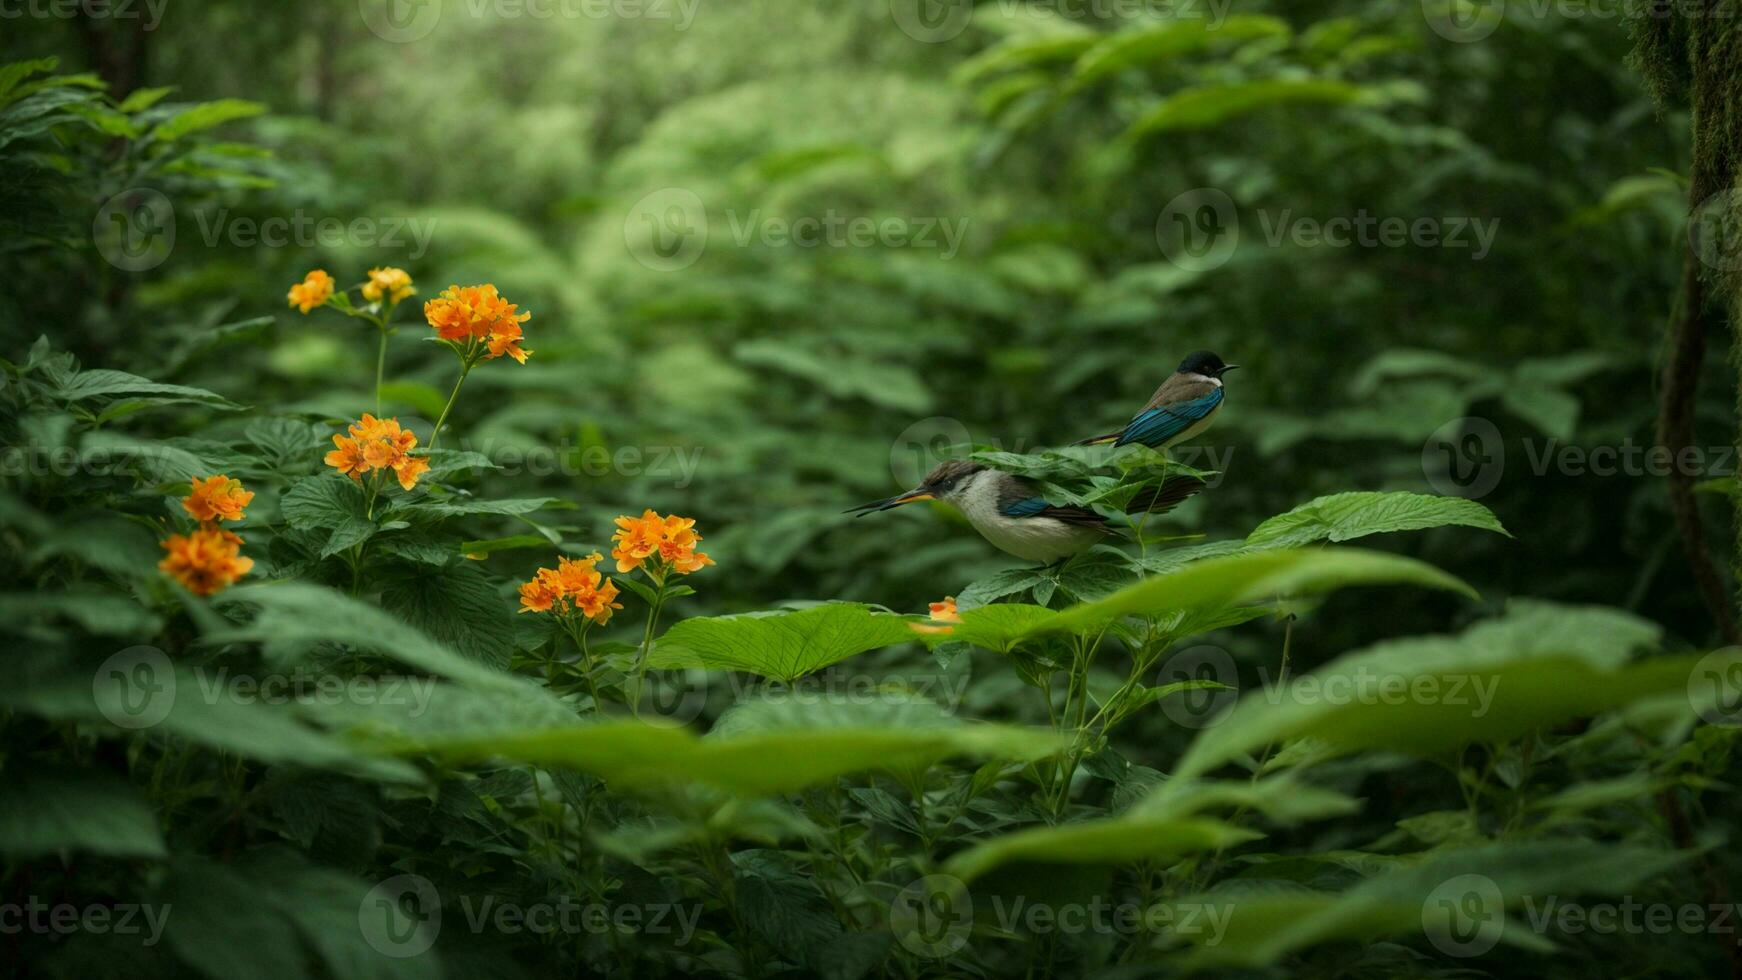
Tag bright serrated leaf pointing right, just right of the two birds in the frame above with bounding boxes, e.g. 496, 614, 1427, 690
1246, 493, 1510, 548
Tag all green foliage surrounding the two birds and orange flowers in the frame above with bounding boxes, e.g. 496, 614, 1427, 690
0, 9, 1742, 980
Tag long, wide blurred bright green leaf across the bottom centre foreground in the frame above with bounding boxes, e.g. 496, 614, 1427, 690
385, 721, 1061, 795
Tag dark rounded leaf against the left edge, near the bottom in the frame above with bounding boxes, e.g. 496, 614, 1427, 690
0, 768, 167, 860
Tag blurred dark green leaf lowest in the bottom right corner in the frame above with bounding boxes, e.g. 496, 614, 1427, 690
1171, 841, 1686, 970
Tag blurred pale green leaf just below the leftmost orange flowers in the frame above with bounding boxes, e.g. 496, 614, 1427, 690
206, 581, 526, 691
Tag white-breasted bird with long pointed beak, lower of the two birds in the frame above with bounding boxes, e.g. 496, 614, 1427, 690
848, 460, 1204, 564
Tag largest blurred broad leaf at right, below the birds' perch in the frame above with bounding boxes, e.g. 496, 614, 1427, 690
1176, 606, 1714, 776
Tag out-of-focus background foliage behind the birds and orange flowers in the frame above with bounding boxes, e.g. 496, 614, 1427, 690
0, 0, 1730, 665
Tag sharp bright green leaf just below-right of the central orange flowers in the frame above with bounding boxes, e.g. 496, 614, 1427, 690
648, 602, 918, 682
